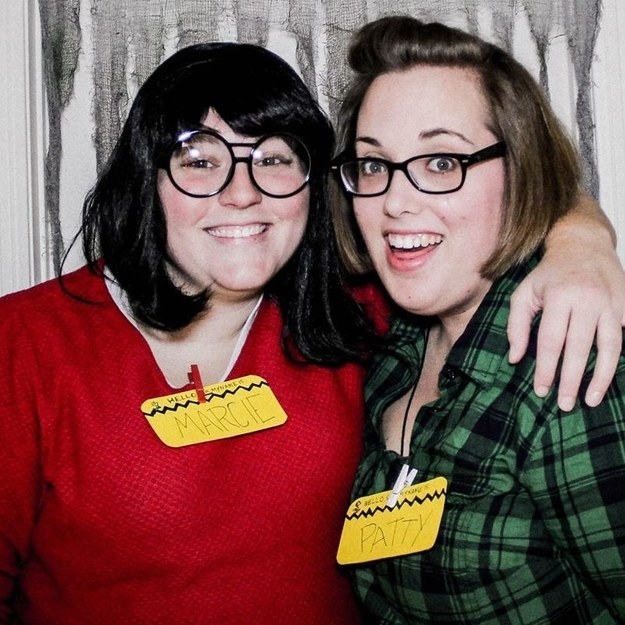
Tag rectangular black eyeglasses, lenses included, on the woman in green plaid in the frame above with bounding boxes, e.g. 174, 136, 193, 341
332, 141, 506, 197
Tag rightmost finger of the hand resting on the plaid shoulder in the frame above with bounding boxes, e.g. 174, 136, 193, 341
584, 315, 623, 407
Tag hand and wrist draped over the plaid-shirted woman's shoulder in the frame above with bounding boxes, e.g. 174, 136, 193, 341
508, 194, 625, 410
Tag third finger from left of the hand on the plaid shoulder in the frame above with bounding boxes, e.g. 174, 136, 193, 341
558, 313, 598, 412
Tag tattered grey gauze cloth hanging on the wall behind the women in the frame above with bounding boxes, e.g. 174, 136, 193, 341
39, 0, 600, 270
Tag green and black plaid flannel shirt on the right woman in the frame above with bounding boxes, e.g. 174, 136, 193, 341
352, 256, 625, 625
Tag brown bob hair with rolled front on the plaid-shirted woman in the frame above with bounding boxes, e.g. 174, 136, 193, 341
333, 16, 580, 280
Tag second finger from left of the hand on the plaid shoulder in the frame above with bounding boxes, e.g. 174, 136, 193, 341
534, 308, 570, 397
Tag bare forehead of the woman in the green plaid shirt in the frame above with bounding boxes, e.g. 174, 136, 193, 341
357, 65, 491, 144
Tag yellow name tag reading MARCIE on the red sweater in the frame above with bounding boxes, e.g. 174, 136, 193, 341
141, 375, 287, 447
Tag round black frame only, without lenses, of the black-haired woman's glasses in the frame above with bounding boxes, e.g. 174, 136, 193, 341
165, 128, 312, 199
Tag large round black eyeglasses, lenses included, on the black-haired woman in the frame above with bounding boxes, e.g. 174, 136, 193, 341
167, 130, 311, 198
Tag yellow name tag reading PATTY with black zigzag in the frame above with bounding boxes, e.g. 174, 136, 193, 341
336, 477, 447, 564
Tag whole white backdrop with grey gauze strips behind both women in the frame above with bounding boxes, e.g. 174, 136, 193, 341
0, 0, 625, 293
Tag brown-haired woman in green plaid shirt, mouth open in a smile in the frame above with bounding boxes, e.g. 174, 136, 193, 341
335, 17, 625, 625
